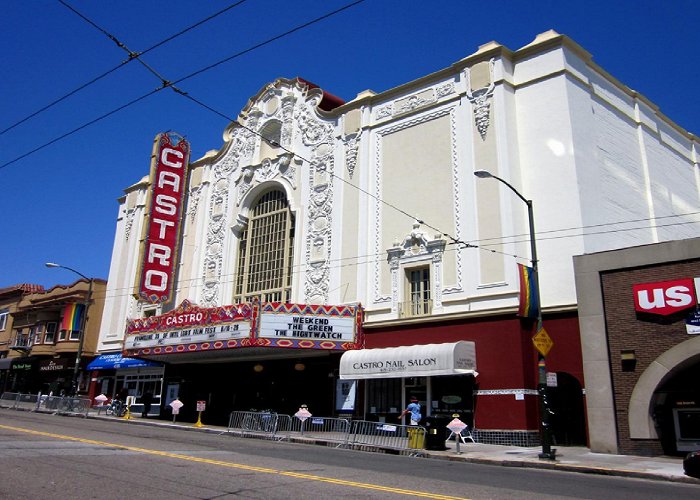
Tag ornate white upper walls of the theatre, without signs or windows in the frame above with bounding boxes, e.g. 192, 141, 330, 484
100, 32, 700, 351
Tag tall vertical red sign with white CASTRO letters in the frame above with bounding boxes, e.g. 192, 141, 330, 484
138, 132, 190, 304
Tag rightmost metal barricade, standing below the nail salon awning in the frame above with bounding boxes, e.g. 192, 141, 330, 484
348, 420, 426, 455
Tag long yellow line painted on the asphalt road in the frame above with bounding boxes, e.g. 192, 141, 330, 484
0, 424, 467, 500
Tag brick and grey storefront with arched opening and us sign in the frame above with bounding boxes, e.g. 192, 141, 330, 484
575, 238, 700, 455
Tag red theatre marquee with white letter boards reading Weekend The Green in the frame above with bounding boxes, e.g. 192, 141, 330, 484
124, 301, 362, 363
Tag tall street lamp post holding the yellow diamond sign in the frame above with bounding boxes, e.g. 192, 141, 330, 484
474, 170, 556, 460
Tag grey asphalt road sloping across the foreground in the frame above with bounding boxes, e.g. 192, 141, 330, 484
0, 409, 700, 500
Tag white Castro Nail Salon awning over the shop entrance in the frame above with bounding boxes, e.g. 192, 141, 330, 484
340, 340, 478, 380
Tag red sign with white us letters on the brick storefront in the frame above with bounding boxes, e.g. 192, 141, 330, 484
632, 278, 697, 316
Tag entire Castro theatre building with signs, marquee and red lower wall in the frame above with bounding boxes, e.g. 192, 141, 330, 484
93, 32, 700, 445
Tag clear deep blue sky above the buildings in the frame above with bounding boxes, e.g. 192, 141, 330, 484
0, 0, 700, 288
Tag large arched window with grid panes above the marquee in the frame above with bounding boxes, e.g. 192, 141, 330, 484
234, 190, 294, 303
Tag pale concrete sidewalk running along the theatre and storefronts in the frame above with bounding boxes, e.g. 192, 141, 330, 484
94, 415, 700, 485
